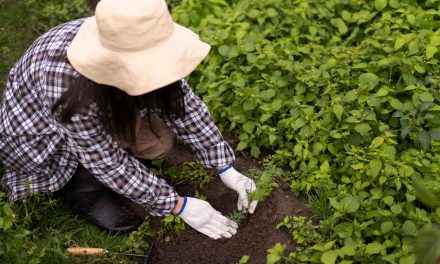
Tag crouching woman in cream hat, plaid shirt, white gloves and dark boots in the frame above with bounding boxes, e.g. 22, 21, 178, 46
0, 0, 257, 239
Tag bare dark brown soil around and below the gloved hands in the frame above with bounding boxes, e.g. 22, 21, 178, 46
142, 142, 311, 264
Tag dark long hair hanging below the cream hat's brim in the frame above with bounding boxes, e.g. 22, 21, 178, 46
52, 76, 185, 142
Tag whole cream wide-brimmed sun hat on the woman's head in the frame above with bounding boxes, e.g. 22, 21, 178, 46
67, 0, 210, 95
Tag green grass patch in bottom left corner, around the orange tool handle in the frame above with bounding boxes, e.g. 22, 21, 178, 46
0, 193, 153, 263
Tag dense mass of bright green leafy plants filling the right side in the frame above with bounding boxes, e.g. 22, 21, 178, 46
174, 0, 440, 263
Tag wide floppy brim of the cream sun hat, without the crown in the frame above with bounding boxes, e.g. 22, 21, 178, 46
67, 17, 210, 96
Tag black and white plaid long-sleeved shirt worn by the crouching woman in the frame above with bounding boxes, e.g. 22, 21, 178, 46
0, 19, 235, 216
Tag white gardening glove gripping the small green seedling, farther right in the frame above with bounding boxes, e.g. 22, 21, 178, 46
217, 165, 258, 214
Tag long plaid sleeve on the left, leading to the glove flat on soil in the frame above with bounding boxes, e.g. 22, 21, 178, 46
59, 108, 178, 216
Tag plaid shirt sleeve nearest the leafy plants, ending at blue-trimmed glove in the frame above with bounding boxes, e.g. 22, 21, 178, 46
166, 80, 235, 168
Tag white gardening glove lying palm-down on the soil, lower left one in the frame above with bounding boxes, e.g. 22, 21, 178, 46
177, 196, 238, 239
